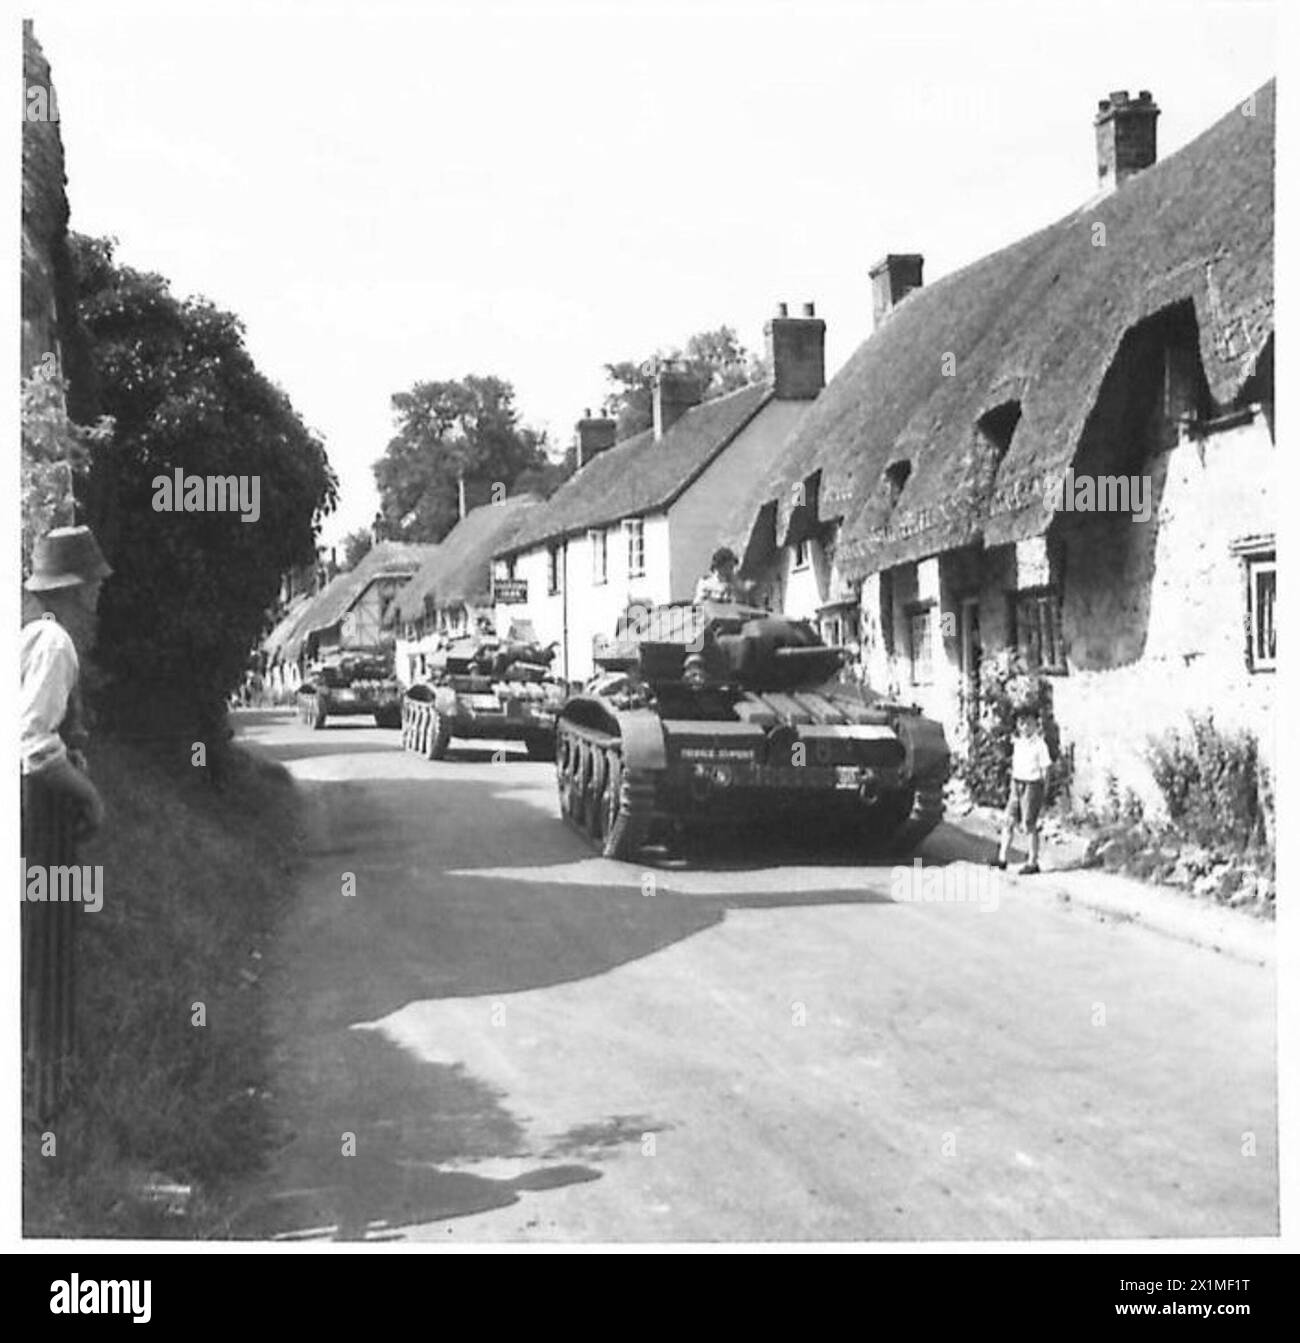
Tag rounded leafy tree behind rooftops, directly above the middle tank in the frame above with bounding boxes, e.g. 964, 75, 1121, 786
375, 373, 567, 541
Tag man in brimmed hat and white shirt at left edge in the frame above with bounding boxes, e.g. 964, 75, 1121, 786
19, 526, 113, 837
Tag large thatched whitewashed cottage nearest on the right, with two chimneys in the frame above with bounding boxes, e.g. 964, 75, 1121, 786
731, 83, 1276, 796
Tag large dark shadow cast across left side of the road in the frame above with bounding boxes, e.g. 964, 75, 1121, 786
231, 729, 993, 1240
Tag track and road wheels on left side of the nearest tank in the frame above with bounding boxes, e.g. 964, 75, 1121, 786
555, 720, 654, 861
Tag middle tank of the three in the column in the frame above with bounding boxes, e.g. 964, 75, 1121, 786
402, 634, 564, 760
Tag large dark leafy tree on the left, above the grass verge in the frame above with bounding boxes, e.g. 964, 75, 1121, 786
71, 235, 337, 735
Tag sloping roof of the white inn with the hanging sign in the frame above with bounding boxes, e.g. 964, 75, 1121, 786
497, 383, 772, 555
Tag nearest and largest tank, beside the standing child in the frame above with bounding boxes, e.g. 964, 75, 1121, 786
556, 602, 949, 860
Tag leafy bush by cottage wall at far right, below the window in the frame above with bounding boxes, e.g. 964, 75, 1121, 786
1148, 713, 1270, 850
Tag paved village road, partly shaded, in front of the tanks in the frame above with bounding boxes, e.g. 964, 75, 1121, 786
228, 713, 1277, 1242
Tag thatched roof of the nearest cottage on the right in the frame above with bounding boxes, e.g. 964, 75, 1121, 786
727, 82, 1274, 579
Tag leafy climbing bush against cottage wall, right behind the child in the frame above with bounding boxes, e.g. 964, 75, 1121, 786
958, 650, 1073, 807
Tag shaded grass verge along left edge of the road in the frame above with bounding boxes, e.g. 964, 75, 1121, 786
23, 740, 302, 1237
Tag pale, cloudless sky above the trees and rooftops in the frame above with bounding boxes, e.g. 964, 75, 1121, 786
27, 0, 1276, 544
